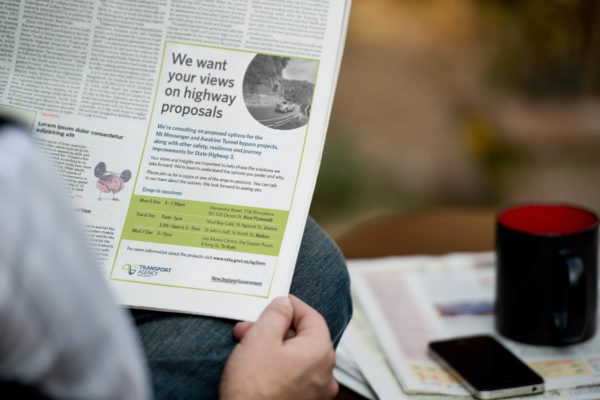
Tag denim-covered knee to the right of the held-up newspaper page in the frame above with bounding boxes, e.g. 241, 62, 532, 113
290, 217, 352, 344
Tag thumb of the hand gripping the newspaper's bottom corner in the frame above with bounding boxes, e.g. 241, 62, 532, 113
244, 296, 294, 340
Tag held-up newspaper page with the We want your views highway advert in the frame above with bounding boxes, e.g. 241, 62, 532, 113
0, 0, 350, 320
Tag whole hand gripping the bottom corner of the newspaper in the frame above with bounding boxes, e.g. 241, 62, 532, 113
220, 295, 338, 400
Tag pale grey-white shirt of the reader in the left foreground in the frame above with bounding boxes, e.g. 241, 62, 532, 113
0, 126, 151, 399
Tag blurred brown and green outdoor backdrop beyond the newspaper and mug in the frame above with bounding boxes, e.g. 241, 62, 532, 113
311, 0, 600, 236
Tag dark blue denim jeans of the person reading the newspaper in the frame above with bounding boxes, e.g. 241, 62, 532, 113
132, 218, 352, 399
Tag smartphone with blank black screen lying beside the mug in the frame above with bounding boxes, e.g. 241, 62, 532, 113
429, 335, 544, 400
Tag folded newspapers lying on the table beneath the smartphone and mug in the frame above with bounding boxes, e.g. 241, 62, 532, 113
347, 253, 600, 399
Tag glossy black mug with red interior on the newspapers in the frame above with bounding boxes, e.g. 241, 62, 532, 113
496, 204, 598, 346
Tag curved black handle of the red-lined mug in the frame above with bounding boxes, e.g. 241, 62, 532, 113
553, 250, 587, 343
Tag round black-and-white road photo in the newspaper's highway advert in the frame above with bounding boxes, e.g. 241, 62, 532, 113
243, 54, 317, 130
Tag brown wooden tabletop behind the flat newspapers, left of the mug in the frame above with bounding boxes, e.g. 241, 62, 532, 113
336, 208, 495, 400
